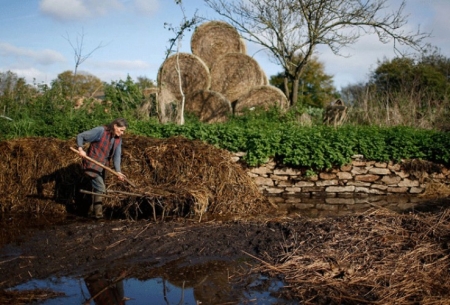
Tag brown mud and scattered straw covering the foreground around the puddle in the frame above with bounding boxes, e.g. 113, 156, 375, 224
0, 199, 450, 304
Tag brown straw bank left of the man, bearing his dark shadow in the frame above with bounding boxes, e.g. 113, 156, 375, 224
0, 138, 82, 213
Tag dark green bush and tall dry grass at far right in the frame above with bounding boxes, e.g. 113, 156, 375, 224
341, 49, 450, 129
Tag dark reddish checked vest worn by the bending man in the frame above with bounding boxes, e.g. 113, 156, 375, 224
83, 126, 120, 178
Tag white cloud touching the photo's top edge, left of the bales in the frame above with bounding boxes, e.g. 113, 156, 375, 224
39, 0, 123, 21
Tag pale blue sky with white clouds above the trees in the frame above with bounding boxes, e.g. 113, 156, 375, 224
0, 0, 450, 90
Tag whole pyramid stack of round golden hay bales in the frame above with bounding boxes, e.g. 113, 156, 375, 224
157, 21, 287, 123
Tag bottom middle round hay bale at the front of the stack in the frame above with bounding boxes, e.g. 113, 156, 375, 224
185, 90, 232, 123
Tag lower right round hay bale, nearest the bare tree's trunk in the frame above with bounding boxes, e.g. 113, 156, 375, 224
234, 85, 288, 114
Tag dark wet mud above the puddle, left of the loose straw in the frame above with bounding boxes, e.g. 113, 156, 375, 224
0, 199, 450, 304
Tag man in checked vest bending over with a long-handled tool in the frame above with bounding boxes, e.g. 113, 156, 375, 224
77, 118, 128, 219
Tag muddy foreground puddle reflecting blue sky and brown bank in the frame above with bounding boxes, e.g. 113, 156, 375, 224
12, 261, 296, 305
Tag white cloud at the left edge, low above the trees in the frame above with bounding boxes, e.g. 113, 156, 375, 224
0, 43, 66, 66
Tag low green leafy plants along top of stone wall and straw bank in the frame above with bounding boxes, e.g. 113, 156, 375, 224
0, 105, 450, 170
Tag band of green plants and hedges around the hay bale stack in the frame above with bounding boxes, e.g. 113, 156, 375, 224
0, 44, 450, 173
